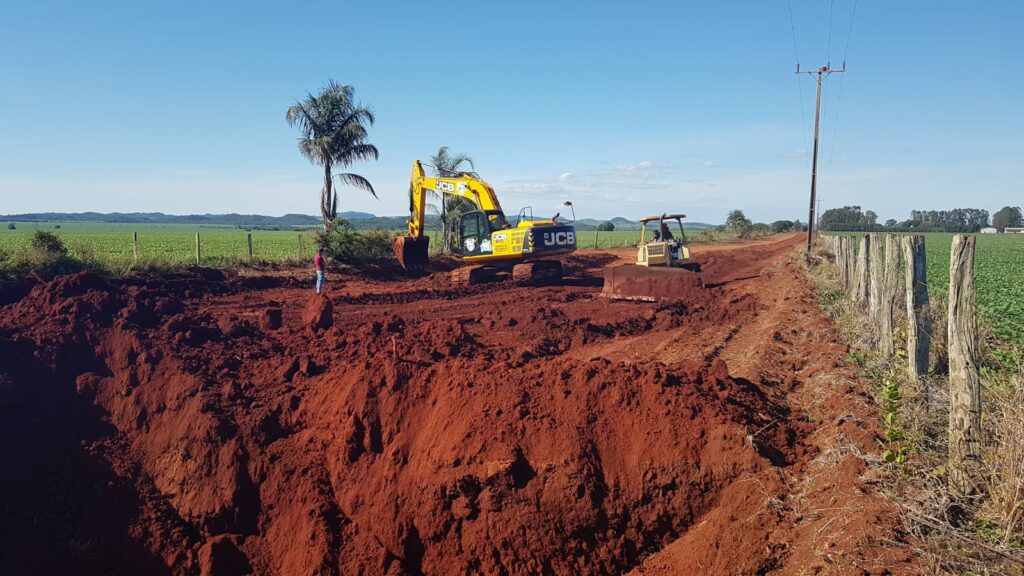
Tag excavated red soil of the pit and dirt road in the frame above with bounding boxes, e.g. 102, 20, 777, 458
0, 237, 908, 575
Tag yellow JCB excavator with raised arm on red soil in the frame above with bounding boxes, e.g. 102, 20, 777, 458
393, 160, 575, 284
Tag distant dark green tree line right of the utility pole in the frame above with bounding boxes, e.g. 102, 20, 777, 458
818, 206, 1022, 234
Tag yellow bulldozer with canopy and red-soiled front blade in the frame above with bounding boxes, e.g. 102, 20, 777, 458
601, 214, 703, 302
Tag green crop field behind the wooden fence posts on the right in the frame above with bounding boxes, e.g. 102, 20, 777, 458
827, 233, 1024, 346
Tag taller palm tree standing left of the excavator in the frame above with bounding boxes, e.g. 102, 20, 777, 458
285, 80, 379, 225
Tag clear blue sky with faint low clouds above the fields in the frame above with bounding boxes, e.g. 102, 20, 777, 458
0, 0, 1024, 222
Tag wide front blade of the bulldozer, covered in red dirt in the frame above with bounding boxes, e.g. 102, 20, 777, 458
601, 264, 705, 302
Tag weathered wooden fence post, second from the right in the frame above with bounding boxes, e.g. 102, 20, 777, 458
903, 236, 932, 379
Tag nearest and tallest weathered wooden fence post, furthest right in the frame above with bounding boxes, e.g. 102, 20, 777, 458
948, 234, 981, 495
